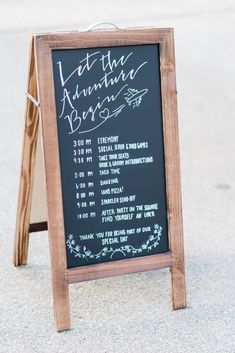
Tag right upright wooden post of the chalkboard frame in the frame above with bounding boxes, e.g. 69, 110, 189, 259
160, 30, 186, 309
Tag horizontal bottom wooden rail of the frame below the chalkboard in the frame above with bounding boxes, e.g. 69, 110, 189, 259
65, 253, 174, 283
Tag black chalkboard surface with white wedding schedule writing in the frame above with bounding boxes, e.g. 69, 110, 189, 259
52, 44, 169, 268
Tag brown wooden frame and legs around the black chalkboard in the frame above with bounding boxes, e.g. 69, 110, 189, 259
14, 28, 186, 331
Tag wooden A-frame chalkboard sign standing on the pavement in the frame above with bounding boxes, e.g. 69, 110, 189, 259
14, 28, 186, 331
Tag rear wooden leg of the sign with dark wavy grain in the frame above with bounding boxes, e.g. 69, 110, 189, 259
13, 39, 39, 266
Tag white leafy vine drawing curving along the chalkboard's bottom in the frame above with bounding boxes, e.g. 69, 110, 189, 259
66, 224, 163, 261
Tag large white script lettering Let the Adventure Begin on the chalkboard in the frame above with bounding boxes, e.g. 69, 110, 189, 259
57, 50, 148, 134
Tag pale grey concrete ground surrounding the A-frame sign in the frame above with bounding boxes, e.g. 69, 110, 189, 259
0, 0, 235, 353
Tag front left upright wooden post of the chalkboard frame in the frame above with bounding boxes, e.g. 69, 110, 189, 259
35, 37, 70, 331
